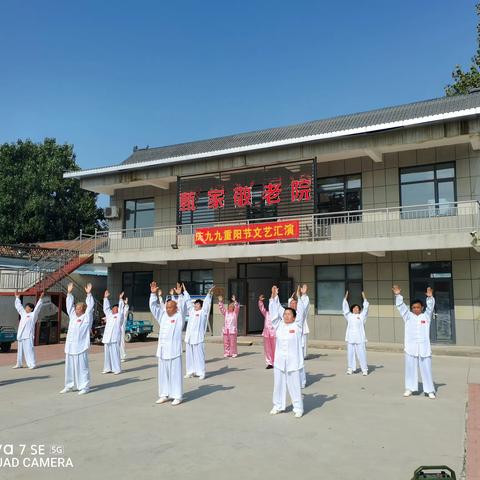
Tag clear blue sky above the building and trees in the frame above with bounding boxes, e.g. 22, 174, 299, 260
0, 0, 477, 177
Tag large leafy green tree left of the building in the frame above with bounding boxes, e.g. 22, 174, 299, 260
0, 138, 104, 243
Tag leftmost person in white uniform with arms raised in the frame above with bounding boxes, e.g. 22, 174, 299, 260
12, 292, 44, 370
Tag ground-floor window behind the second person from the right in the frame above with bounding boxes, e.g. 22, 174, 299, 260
316, 265, 363, 315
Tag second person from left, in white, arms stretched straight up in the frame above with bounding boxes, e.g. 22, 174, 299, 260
60, 283, 95, 395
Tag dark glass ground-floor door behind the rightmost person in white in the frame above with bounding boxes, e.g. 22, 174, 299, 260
410, 262, 455, 343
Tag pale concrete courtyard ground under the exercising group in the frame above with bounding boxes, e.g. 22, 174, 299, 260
0, 343, 480, 480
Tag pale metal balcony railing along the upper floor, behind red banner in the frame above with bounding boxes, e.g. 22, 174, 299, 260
94, 201, 480, 252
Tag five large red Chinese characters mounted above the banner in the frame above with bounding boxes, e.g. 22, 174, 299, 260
179, 176, 313, 212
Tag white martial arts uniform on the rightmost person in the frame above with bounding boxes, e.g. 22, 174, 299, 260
395, 295, 435, 393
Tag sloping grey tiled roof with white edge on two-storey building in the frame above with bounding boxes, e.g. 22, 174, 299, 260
65, 91, 480, 178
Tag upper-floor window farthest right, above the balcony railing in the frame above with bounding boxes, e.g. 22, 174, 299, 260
400, 162, 456, 218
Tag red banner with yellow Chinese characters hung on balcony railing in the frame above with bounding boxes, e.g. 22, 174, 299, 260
195, 220, 300, 245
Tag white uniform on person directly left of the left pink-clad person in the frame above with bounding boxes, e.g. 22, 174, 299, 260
183, 291, 212, 378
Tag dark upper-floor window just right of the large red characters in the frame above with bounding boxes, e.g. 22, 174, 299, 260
317, 174, 362, 213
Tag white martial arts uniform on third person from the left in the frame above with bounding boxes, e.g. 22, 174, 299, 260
102, 297, 125, 374
